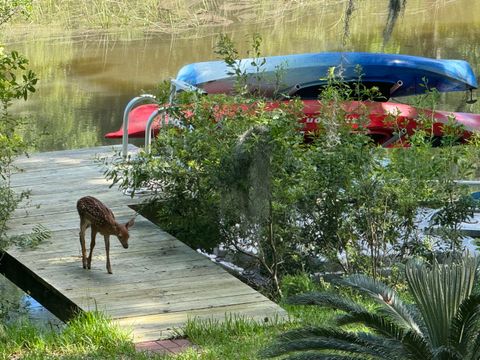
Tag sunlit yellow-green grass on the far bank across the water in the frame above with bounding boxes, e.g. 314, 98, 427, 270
16, 0, 326, 33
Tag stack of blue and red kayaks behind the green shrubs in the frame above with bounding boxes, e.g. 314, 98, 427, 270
106, 52, 480, 144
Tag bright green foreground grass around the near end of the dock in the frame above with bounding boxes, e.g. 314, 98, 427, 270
0, 306, 333, 360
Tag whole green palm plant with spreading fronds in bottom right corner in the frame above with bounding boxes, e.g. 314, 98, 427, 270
263, 256, 480, 360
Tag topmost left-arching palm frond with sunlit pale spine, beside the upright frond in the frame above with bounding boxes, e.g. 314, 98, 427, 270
340, 274, 421, 334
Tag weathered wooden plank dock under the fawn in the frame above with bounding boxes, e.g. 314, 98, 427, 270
0, 147, 285, 342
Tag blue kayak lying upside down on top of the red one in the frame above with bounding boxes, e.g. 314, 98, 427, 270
176, 52, 478, 100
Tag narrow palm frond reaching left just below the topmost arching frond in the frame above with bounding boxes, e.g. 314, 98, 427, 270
287, 292, 367, 312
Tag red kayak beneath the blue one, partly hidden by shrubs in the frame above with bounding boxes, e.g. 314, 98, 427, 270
105, 100, 480, 144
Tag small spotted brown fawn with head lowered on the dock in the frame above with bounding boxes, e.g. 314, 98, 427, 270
77, 196, 135, 274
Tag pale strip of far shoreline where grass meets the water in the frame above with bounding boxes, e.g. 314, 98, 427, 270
0, 0, 324, 45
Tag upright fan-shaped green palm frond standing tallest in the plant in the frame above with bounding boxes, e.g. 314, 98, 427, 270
405, 256, 477, 348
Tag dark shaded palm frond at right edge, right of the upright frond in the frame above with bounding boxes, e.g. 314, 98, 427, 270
450, 294, 480, 356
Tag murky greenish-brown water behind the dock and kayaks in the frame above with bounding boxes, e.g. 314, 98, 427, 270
3, 0, 480, 151
